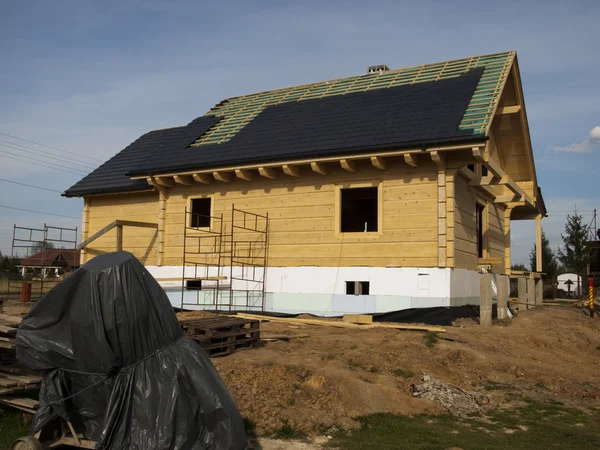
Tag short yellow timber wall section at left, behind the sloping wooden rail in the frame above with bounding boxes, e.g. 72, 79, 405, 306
84, 192, 158, 265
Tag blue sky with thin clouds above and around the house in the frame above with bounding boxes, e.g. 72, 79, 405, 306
0, 0, 600, 262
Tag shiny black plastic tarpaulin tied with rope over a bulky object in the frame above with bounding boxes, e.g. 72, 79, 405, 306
16, 252, 247, 450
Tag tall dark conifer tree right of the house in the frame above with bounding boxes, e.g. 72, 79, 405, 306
558, 211, 589, 279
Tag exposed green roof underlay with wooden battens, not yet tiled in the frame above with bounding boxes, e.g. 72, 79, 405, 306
192, 51, 515, 145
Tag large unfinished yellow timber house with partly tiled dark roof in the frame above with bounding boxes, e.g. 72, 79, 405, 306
64, 52, 546, 315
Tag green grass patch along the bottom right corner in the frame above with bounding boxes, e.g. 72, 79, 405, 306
328, 399, 600, 450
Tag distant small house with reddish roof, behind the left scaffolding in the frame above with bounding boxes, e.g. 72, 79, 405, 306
16, 248, 81, 278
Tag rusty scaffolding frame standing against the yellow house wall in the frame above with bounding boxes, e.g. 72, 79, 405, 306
181, 204, 269, 312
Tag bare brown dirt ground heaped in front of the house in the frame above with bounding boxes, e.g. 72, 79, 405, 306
205, 307, 600, 435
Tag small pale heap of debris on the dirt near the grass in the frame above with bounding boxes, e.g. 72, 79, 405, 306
410, 375, 490, 417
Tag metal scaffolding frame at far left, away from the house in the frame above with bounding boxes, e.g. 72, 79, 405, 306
7, 223, 79, 298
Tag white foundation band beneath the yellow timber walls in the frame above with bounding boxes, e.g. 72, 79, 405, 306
147, 266, 497, 316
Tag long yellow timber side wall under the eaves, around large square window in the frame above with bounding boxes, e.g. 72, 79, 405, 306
164, 161, 438, 267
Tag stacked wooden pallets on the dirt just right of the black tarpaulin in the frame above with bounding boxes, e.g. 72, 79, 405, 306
179, 316, 260, 357
